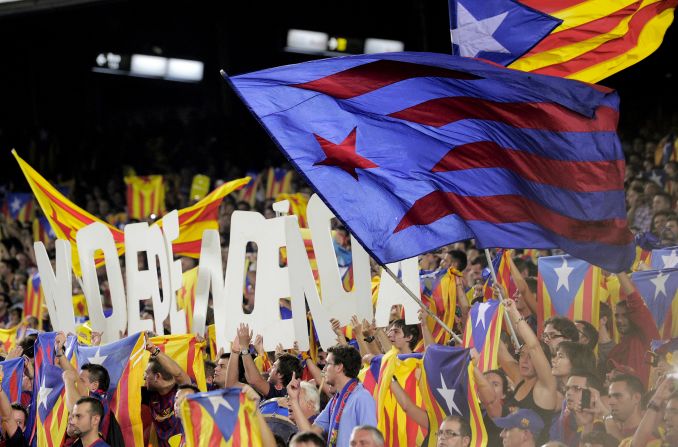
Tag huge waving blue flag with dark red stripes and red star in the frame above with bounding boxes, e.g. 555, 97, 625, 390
227, 53, 634, 271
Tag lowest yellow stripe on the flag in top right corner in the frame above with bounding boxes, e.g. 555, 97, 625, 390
568, 5, 673, 83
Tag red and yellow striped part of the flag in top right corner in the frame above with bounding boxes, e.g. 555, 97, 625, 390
509, 0, 678, 83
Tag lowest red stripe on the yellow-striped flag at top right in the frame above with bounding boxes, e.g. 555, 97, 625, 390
533, 0, 678, 76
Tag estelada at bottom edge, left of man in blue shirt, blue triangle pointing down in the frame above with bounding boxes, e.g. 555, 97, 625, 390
180, 388, 262, 447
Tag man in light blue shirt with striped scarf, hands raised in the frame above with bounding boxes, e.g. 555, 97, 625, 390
287, 345, 377, 447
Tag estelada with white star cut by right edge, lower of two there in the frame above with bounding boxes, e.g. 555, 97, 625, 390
631, 269, 678, 339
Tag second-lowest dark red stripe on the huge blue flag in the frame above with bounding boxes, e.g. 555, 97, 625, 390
432, 141, 624, 192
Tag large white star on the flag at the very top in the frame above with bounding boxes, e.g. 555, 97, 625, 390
450, 2, 509, 57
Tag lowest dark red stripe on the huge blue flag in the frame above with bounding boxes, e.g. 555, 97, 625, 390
394, 191, 633, 245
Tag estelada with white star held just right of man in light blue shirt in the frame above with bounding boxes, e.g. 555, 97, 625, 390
420, 345, 487, 447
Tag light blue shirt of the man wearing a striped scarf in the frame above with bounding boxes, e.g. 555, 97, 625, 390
313, 383, 377, 446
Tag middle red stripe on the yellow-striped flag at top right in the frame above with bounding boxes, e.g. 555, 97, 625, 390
522, 1, 641, 58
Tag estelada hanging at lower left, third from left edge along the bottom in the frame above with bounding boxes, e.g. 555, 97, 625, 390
75, 334, 146, 447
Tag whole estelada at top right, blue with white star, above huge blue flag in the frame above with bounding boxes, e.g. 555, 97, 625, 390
449, 0, 678, 83
